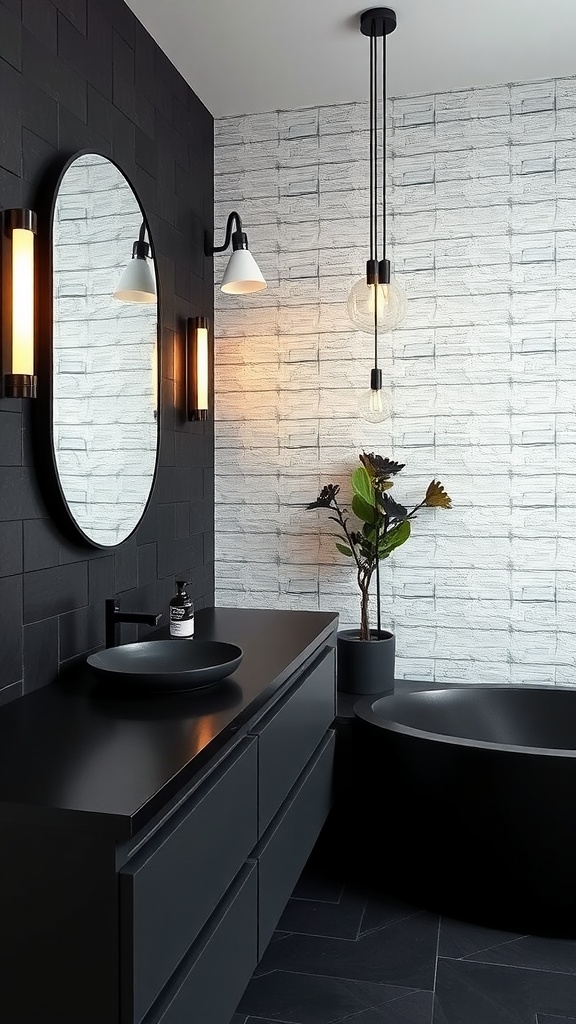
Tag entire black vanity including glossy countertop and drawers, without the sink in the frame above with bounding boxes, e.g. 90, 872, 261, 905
0, 608, 337, 1024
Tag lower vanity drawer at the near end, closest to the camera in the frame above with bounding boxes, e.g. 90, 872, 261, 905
145, 863, 257, 1024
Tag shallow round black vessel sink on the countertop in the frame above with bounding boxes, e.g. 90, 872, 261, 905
86, 640, 243, 694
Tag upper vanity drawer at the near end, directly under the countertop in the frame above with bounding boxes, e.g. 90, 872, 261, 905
120, 738, 257, 1024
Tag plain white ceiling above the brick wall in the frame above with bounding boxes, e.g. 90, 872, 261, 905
127, 0, 576, 117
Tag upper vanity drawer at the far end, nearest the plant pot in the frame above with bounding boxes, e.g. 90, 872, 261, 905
251, 648, 335, 836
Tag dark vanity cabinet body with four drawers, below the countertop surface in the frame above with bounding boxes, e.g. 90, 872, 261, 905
0, 613, 335, 1024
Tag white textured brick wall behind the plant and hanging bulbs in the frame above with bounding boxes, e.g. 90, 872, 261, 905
215, 78, 576, 685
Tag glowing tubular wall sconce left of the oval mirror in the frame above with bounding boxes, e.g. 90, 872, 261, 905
1, 210, 37, 398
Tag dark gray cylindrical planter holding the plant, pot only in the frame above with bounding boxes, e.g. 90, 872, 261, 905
336, 630, 396, 693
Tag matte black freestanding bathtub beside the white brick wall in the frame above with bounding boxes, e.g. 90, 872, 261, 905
355, 686, 576, 937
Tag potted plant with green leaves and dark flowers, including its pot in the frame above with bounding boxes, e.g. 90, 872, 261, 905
306, 452, 452, 693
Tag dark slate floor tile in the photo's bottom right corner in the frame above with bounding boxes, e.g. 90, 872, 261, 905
434, 959, 576, 1024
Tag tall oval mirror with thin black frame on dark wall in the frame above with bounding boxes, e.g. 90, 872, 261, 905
52, 154, 159, 547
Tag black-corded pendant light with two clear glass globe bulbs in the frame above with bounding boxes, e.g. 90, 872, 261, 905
347, 7, 406, 423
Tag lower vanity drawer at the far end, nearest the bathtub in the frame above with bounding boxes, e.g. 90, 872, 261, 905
257, 731, 335, 959
